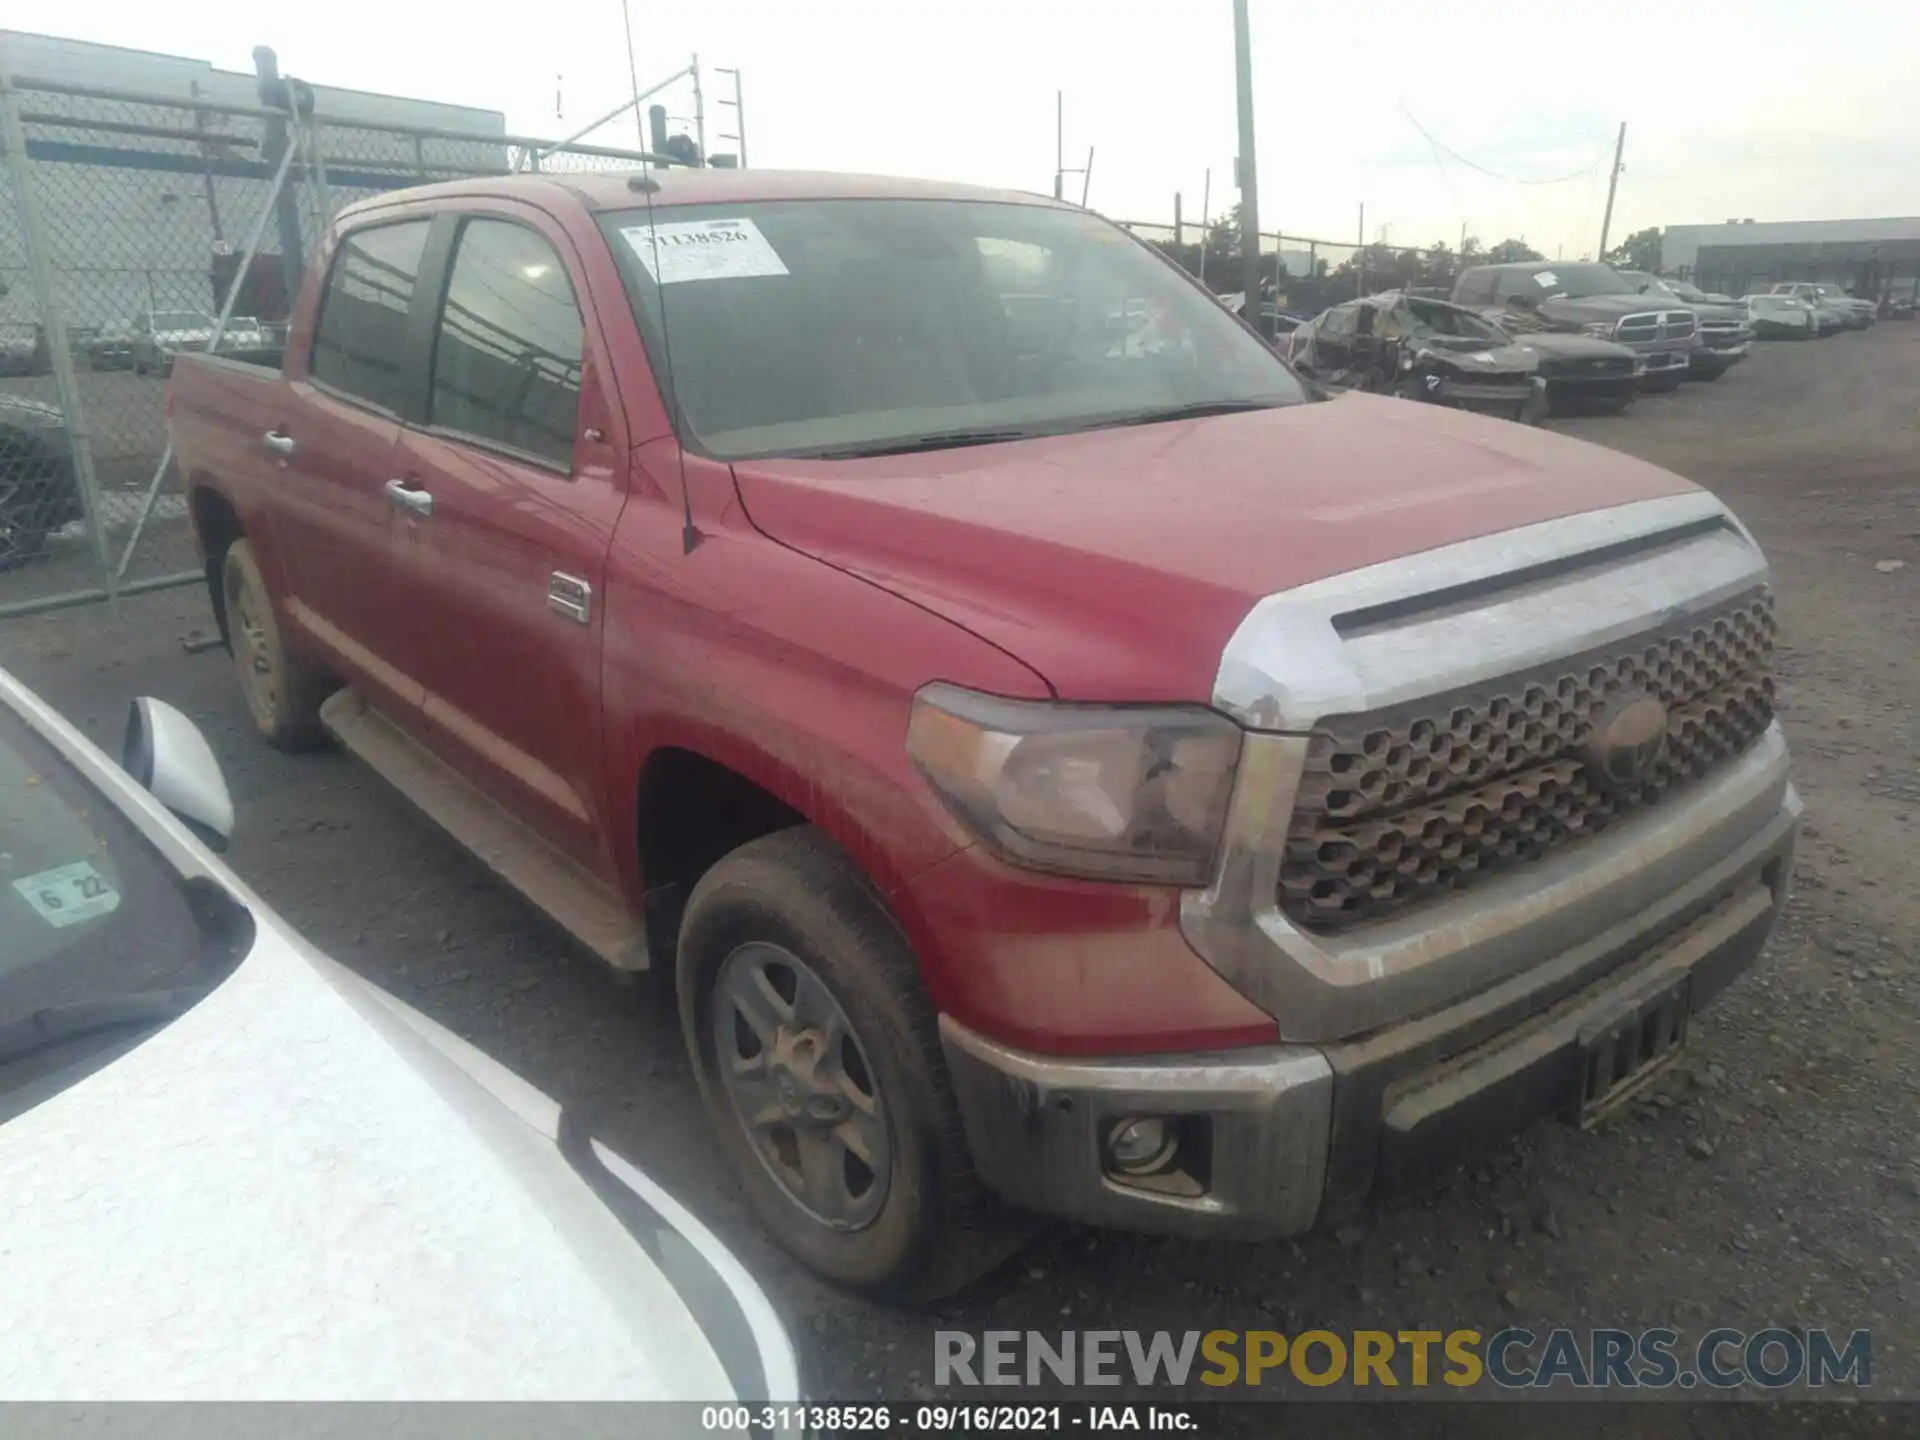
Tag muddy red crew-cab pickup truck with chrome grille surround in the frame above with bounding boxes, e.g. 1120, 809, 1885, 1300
167, 169, 1801, 1296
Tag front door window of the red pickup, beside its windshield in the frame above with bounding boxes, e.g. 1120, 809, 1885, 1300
430, 219, 582, 470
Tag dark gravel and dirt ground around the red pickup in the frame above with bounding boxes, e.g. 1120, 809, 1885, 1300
0, 323, 1920, 1396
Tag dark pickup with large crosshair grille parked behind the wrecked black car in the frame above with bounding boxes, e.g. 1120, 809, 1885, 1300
1453, 261, 1701, 390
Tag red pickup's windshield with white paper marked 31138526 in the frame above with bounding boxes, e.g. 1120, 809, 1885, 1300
603, 200, 1309, 459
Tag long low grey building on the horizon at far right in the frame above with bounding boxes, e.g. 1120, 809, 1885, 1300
1661, 217, 1920, 300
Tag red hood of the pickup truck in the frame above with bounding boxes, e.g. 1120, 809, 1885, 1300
733, 394, 1692, 703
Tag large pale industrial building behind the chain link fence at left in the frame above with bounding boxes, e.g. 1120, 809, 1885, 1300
0, 31, 511, 332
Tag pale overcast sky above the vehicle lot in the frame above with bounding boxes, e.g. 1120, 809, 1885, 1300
15, 0, 1920, 257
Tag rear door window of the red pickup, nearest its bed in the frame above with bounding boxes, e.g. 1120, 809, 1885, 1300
307, 221, 428, 415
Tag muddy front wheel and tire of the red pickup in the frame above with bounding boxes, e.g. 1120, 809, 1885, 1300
676, 826, 1033, 1304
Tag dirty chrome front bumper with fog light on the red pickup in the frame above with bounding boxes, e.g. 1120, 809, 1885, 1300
941, 785, 1801, 1236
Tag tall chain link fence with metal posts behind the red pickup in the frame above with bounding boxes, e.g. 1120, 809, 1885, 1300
0, 67, 641, 616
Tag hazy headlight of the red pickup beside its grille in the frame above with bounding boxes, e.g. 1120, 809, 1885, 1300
906, 684, 1240, 885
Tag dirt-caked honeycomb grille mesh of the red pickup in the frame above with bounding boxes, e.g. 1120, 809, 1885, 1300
1279, 591, 1774, 933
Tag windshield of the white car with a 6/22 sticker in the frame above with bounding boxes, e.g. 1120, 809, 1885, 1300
0, 705, 240, 1123
